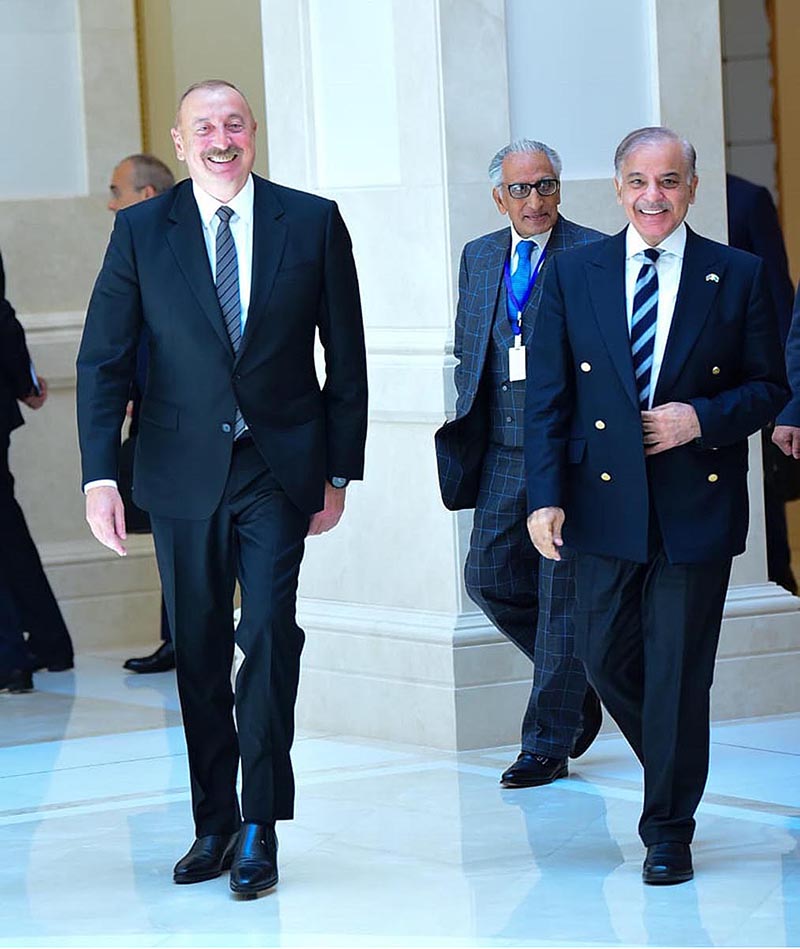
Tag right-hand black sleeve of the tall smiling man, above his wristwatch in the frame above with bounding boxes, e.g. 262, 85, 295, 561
319, 204, 367, 480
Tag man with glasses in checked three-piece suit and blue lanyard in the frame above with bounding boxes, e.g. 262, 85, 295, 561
436, 139, 603, 787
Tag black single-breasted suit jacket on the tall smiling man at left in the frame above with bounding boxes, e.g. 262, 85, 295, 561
78, 175, 367, 518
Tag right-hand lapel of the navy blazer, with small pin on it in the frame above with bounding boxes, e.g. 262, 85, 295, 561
653, 227, 725, 404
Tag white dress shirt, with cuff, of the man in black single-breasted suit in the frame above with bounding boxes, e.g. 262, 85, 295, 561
83, 175, 255, 493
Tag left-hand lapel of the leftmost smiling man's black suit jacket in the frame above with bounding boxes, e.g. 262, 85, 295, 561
167, 181, 233, 352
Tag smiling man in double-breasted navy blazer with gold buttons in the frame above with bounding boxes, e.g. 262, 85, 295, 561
525, 128, 787, 884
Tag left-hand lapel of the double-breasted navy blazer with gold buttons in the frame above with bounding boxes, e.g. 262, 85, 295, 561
586, 230, 639, 408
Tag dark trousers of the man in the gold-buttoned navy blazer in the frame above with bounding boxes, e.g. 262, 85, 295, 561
575, 544, 731, 846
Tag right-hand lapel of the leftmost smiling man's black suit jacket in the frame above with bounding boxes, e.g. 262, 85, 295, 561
236, 175, 288, 361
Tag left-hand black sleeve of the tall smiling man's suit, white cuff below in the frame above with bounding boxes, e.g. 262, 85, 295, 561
77, 214, 142, 484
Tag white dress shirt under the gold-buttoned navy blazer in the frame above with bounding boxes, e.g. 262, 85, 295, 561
625, 224, 686, 408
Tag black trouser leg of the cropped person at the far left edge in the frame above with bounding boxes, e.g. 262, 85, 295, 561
0, 433, 73, 665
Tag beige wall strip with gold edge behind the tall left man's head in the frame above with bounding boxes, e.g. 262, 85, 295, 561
135, 0, 267, 178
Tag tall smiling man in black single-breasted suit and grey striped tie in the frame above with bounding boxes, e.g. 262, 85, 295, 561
78, 80, 367, 896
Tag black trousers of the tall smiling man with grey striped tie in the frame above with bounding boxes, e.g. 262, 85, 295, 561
151, 440, 309, 837
